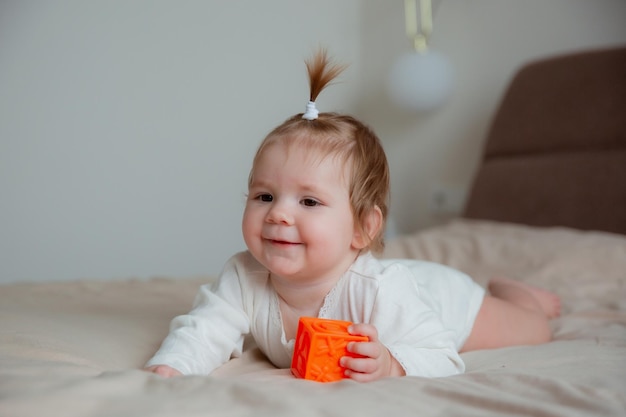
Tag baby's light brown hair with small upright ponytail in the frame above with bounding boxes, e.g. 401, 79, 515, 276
248, 50, 389, 251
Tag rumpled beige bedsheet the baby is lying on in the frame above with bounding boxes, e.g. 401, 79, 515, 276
0, 221, 626, 417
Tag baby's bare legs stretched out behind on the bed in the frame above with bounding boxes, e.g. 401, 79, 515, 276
461, 278, 561, 352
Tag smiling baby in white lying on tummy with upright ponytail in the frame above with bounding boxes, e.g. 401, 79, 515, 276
146, 51, 560, 381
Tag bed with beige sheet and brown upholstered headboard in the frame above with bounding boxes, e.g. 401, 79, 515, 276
0, 48, 626, 417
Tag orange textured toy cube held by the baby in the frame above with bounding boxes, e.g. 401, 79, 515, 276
291, 317, 369, 382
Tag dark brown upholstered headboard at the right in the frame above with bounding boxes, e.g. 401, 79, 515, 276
464, 47, 626, 234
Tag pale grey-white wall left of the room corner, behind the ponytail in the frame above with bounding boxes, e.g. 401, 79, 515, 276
0, 0, 360, 282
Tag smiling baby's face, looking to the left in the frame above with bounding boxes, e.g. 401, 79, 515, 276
242, 143, 358, 283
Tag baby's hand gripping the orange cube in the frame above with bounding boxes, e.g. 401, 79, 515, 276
339, 323, 405, 382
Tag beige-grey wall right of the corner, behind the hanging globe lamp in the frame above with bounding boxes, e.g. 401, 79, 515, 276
359, 0, 626, 232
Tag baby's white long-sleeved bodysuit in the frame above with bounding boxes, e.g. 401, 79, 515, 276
147, 252, 485, 377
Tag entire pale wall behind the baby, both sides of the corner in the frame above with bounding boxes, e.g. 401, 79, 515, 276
0, 0, 626, 282
